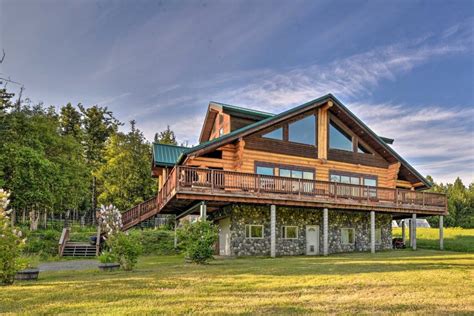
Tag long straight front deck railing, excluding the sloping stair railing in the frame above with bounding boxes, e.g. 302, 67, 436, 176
173, 166, 446, 207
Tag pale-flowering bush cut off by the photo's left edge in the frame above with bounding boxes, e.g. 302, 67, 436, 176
0, 189, 26, 284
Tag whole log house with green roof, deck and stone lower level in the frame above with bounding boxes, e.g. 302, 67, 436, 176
123, 94, 447, 256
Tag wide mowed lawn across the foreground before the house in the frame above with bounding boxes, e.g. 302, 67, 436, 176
0, 250, 474, 315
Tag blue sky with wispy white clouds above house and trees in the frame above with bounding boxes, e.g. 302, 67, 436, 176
0, 0, 474, 182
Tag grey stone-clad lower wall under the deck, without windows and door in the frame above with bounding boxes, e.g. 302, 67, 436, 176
210, 204, 392, 256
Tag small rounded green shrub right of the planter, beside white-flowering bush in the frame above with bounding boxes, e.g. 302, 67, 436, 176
107, 232, 142, 270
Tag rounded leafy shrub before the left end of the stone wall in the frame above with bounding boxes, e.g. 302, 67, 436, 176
178, 221, 218, 264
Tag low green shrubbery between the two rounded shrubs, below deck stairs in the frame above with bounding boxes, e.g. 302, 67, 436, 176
130, 229, 176, 255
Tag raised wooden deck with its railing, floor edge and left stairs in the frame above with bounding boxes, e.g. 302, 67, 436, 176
122, 166, 447, 229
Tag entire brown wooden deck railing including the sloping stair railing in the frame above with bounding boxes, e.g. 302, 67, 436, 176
122, 166, 447, 229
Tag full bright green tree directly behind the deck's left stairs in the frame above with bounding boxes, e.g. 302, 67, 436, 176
95, 121, 156, 211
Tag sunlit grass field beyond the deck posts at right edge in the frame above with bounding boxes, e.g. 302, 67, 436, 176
392, 227, 474, 252
